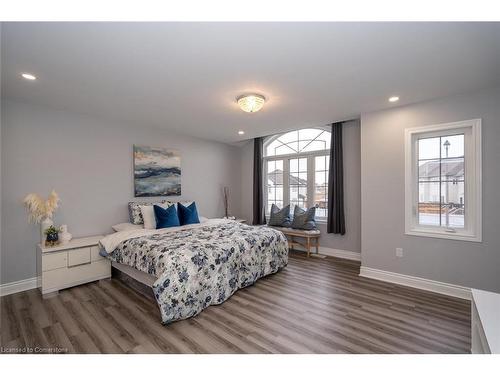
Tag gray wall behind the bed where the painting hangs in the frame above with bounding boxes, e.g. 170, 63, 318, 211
1, 101, 241, 283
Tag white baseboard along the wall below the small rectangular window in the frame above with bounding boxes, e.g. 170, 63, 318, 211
359, 266, 472, 300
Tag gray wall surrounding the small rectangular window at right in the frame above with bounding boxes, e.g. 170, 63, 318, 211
361, 89, 500, 292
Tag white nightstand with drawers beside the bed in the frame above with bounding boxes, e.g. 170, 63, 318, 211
36, 236, 111, 297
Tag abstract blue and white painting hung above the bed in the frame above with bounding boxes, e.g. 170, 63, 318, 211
134, 145, 181, 197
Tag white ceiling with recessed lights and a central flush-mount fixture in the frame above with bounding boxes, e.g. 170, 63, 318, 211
2, 23, 500, 143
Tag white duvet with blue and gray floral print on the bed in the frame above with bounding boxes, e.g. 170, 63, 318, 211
100, 219, 288, 324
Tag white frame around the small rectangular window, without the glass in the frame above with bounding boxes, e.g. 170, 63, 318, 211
405, 119, 482, 242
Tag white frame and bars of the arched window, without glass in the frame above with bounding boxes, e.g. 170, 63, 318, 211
262, 126, 331, 223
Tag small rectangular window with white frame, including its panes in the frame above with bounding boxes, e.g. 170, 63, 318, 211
405, 120, 481, 241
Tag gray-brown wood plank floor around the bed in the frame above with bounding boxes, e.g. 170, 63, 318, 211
0, 254, 470, 353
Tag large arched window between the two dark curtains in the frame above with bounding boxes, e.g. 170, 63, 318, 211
264, 128, 331, 221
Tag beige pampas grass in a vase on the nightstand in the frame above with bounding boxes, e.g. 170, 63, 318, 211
23, 190, 60, 244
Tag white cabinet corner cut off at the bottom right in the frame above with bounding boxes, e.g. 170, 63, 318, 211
471, 289, 500, 354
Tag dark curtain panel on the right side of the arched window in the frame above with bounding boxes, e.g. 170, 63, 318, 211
326, 122, 345, 234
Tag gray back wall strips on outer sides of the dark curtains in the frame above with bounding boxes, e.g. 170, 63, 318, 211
241, 121, 361, 253
